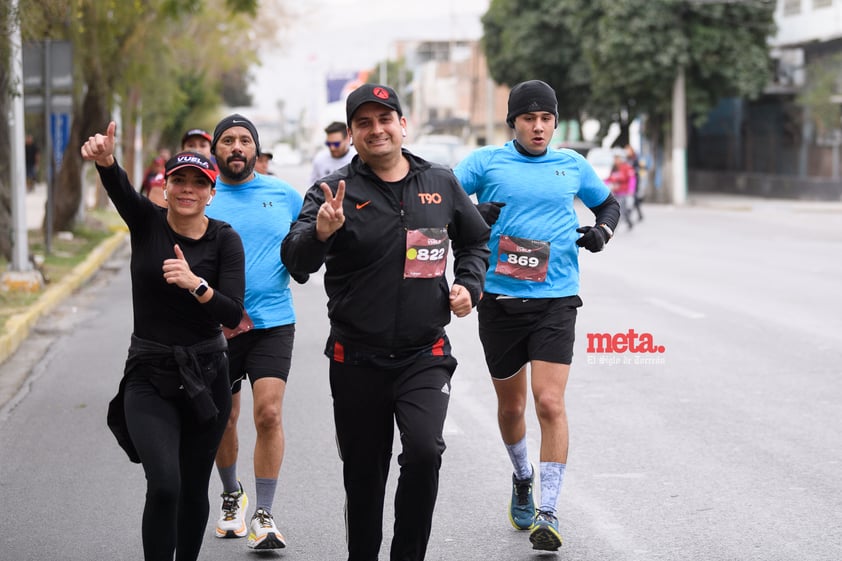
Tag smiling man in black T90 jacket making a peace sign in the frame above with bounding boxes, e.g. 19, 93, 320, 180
281, 84, 489, 561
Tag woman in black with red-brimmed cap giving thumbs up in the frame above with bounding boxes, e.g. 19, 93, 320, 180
82, 121, 245, 561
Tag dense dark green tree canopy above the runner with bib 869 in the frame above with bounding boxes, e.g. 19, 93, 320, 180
483, 0, 775, 147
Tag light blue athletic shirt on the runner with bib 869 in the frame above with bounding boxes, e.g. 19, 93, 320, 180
453, 141, 611, 298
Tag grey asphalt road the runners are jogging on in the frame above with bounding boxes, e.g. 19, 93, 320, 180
0, 163, 842, 561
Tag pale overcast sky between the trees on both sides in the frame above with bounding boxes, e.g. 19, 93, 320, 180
246, 0, 489, 122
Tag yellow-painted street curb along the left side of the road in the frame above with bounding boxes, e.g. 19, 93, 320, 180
0, 230, 128, 364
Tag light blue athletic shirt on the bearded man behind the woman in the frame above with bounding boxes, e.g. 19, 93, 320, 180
206, 173, 303, 329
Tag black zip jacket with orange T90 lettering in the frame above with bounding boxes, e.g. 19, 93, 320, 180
281, 150, 490, 354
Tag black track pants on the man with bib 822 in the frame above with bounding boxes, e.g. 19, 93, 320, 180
330, 356, 456, 561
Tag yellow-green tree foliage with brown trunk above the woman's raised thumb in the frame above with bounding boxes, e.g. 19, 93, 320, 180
8, 0, 270, 231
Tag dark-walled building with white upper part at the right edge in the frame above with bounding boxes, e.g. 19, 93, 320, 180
687, 0, 842, 200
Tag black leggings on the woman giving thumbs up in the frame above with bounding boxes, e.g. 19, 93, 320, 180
124, 359, 231, 561
